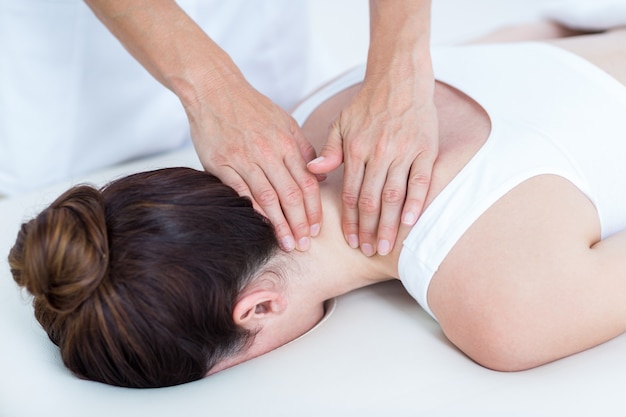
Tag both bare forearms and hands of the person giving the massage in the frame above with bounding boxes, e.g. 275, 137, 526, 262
85, 0, 438, 255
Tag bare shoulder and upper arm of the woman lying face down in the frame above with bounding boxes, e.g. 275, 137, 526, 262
428, 175, 626, 371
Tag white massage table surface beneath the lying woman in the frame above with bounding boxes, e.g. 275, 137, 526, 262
0, 0, 626, 417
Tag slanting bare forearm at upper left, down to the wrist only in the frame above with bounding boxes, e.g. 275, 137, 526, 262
85, 0, 243, 111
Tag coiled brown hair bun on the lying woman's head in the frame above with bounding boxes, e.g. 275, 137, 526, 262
9, 185, 109, 313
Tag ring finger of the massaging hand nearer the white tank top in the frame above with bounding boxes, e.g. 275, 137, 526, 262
376, 164, 411, 256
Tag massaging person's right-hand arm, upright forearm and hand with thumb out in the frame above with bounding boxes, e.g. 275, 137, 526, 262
309, 0, 438, 255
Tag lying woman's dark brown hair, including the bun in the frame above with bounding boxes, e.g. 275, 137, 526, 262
9, 168, 278, 387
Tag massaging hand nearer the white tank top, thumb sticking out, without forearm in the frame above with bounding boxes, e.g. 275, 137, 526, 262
308, 67, 439, 256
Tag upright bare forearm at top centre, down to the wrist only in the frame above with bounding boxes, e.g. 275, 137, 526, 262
367, 0, 432, 88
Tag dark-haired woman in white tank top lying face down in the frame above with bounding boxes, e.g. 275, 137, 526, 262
9, 25, 626, 387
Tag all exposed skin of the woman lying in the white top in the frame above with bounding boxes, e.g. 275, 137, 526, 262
211, 27, 626, 373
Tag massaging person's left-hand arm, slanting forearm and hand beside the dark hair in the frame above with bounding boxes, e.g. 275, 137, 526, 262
85, 0, 322, 250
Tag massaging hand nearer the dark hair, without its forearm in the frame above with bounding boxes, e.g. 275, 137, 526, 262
187, 77, 322, 251
